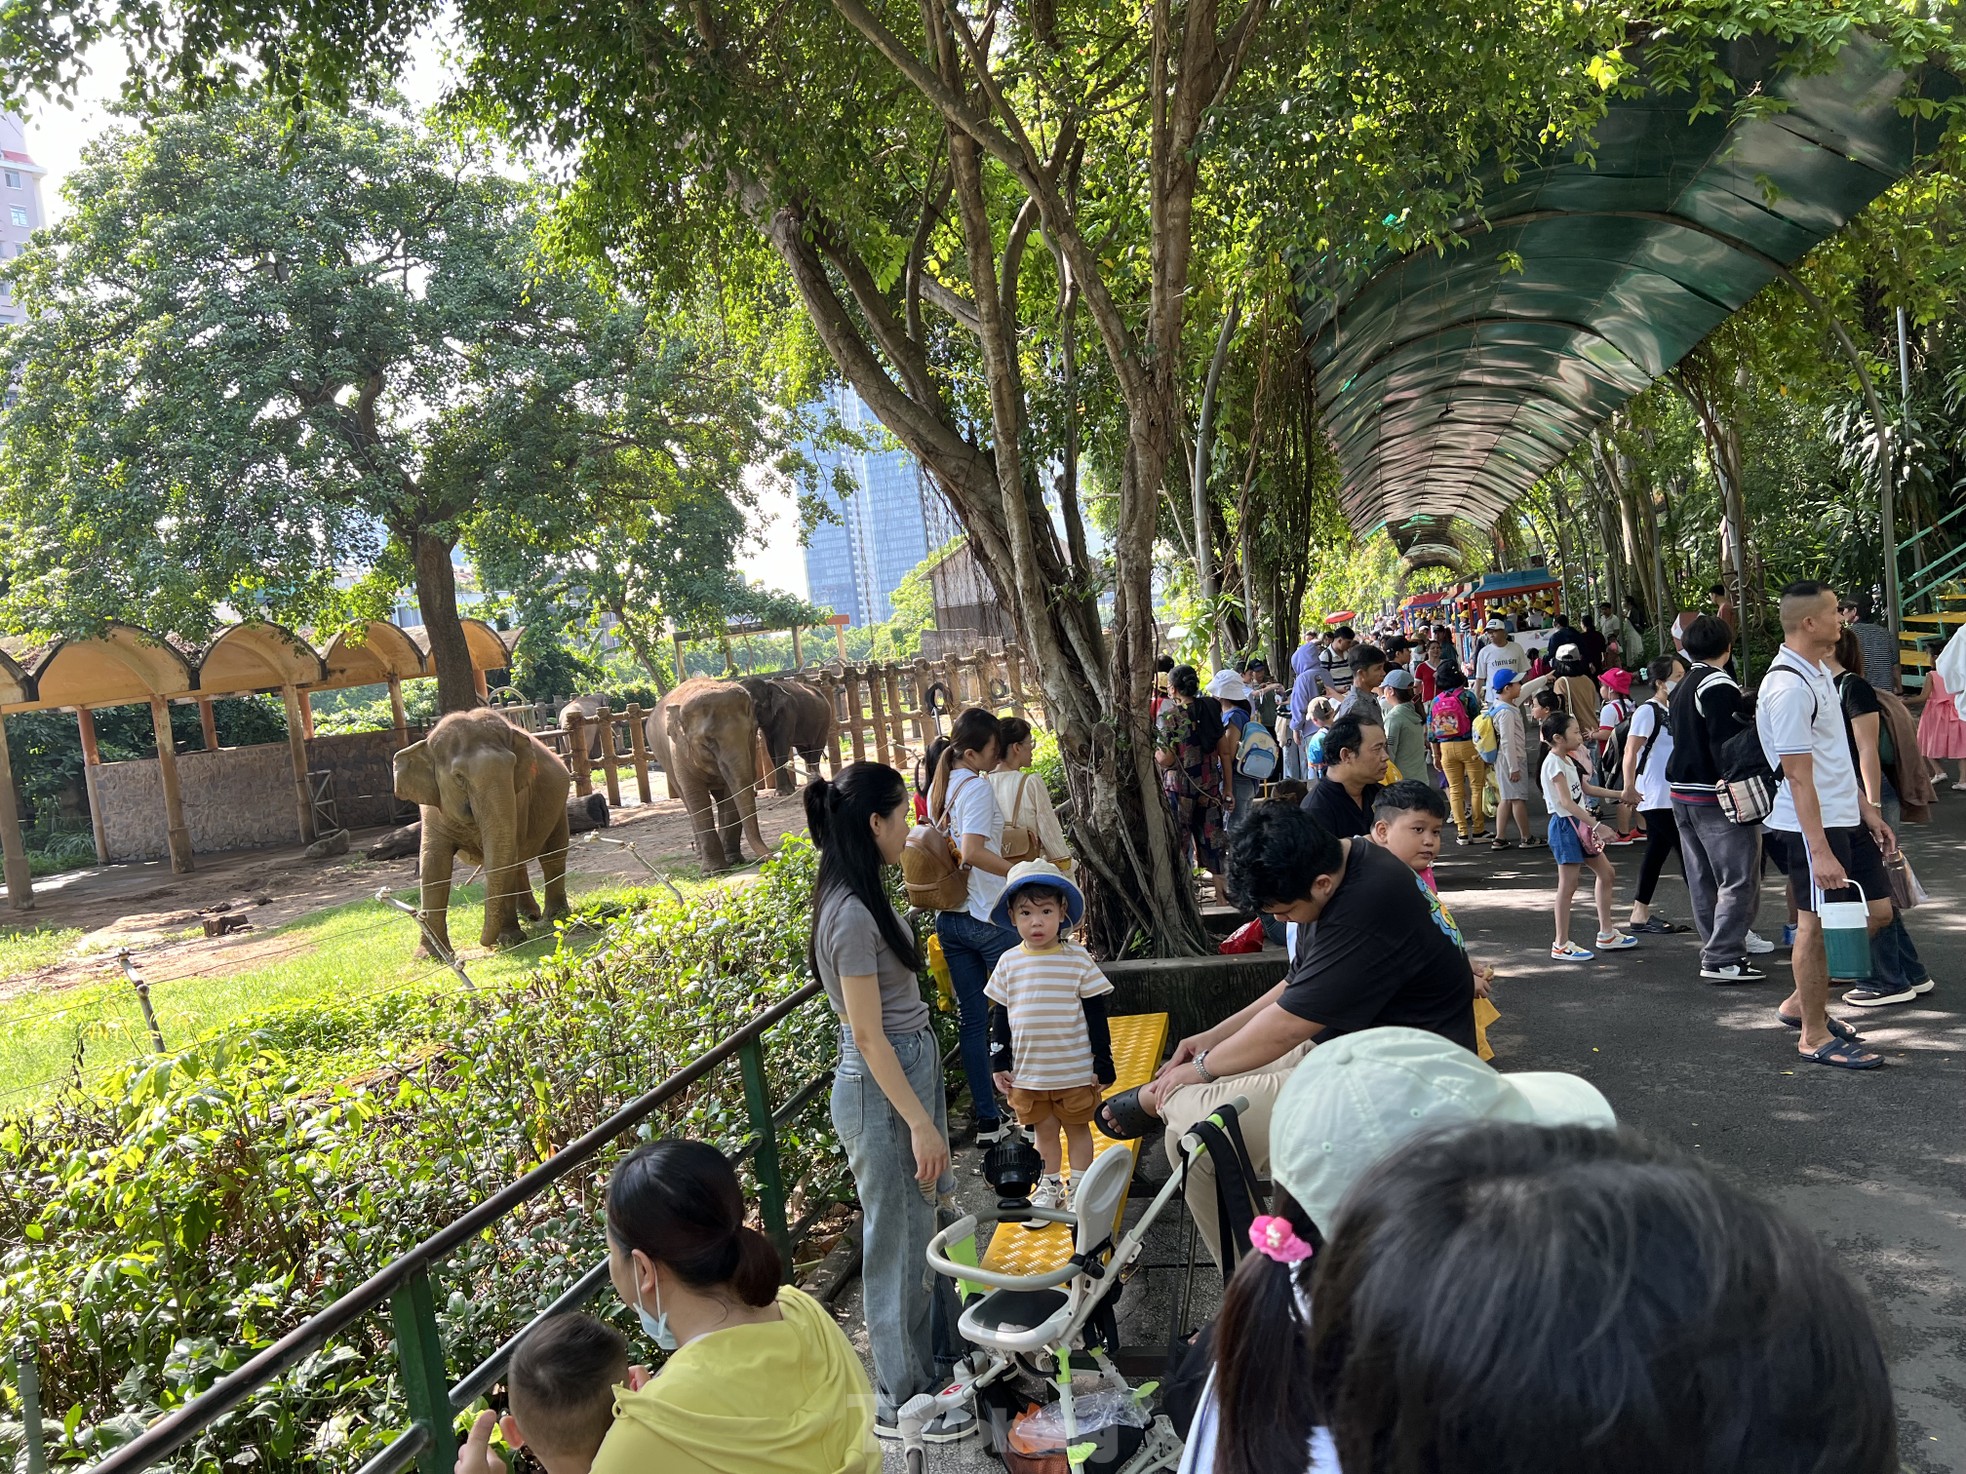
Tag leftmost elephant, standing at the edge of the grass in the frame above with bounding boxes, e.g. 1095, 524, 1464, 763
395, 708, 572, 953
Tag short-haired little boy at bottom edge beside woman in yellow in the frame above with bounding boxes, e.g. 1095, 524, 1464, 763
458, 1315, 631, 1474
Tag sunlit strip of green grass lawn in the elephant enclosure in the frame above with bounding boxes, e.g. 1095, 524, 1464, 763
0, 873, 716, 1114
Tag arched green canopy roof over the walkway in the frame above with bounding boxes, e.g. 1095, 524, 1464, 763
1303, 37, 1958, 562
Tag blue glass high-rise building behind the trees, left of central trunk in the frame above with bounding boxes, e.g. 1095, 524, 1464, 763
806, 387, 959, 625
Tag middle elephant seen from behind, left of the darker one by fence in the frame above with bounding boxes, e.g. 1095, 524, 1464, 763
649, 676, 769, 871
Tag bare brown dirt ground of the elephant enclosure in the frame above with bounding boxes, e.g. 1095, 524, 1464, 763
0, 774, 806, 1000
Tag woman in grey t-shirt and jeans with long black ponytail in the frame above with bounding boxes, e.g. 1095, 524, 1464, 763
806, 763, 975, 1443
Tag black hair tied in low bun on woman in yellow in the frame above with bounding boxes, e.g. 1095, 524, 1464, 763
607, 1138, 784, 1307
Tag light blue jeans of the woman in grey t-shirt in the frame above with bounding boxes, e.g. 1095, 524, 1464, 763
832, 1028, 955, 1421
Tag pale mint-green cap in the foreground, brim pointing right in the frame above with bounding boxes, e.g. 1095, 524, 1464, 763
1270, 1026, 1618, 1234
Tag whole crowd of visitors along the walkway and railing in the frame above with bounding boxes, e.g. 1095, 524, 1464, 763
458, 582, 1966, 1474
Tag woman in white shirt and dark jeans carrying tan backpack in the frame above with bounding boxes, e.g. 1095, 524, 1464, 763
928, 706, 1020, 1150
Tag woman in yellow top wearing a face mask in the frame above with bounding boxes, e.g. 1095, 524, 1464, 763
592, 1140, 881, 1474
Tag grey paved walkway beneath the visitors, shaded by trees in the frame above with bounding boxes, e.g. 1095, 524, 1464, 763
849, 794, 1966, 1474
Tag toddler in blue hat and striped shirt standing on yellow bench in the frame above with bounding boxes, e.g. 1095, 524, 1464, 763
983, 859, 1113, 1228
